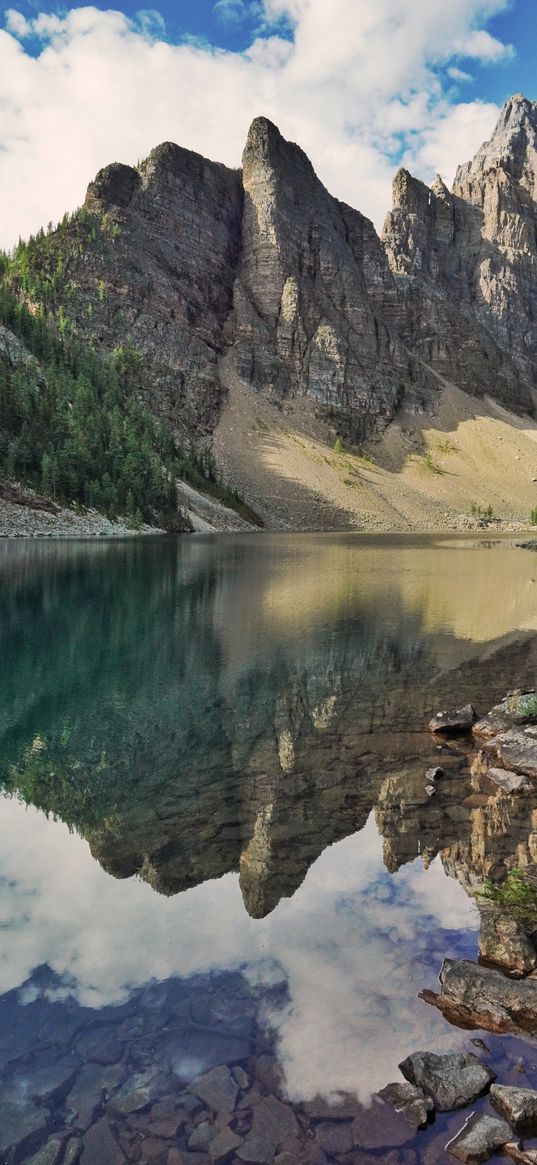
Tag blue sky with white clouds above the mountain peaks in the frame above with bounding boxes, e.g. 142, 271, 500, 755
0, 0, 537, 248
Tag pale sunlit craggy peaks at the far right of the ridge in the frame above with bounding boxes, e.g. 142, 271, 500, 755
383, 97, 537, 410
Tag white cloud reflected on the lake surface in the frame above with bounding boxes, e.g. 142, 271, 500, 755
0, 798, 478, 1102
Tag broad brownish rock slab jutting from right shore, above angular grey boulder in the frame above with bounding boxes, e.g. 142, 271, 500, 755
418, 959, 537, 1034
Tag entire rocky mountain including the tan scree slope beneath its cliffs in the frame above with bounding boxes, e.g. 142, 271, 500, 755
0, 97, 537, 528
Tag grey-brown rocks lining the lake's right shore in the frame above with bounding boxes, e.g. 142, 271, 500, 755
380, 690, 537, 1165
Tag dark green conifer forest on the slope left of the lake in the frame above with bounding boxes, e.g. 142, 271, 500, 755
0, 251, 259, 529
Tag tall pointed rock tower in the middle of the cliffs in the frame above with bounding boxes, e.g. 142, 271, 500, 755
229, 118, 412, 437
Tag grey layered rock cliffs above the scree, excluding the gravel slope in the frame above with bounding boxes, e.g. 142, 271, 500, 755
10, 97, 537, 454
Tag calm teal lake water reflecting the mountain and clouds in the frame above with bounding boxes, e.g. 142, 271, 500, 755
0, 536, 537, 1165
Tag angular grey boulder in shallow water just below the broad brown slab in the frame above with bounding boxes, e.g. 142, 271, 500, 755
400, 1052, 496, 1113
